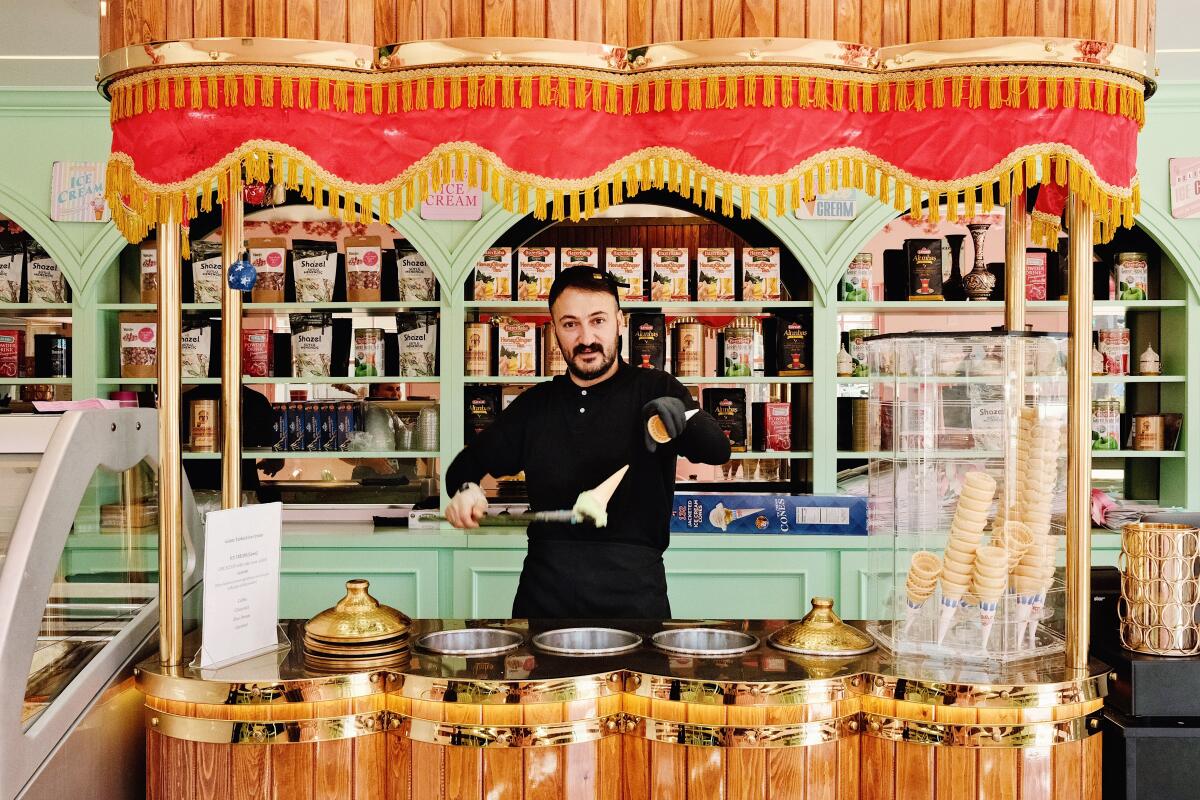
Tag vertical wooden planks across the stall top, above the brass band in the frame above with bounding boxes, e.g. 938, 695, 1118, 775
100, 0, 1154, 53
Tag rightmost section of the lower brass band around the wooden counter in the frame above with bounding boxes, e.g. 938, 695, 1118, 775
862, 711, 1103, 748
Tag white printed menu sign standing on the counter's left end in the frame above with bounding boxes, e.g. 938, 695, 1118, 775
198, 503, 283, 668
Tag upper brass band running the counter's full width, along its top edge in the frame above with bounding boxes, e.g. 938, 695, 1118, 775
134, 668, 1109, 709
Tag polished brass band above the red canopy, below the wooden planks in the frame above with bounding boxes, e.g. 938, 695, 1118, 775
96, 36, 1154, 92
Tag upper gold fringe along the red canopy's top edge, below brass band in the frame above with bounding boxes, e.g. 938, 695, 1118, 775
109, 65, 1146, 127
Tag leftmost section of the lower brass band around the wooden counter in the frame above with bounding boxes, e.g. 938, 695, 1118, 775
145, 709, 400, 745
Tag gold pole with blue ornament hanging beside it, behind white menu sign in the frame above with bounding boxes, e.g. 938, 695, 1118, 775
221, 169, 244, 509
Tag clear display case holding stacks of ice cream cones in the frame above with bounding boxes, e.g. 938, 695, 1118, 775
866, 333, 1067, 662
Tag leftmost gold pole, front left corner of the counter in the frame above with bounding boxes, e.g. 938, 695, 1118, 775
157, 203, 184, 667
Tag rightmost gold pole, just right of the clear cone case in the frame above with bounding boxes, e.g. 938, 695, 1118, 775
1067, 193, 1092, 669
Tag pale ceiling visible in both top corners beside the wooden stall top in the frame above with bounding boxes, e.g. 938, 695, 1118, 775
0, 0, 1200, 86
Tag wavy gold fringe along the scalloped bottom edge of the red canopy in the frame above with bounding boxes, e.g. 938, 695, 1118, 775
106, 140, 1141, 242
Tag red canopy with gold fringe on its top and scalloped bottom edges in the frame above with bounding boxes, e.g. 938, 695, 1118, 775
107, 58, 1145, 241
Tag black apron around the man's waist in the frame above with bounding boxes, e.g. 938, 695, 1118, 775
512, 540, 671, 620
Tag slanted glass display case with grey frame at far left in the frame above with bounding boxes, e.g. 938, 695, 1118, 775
0, 409, 202, 798
